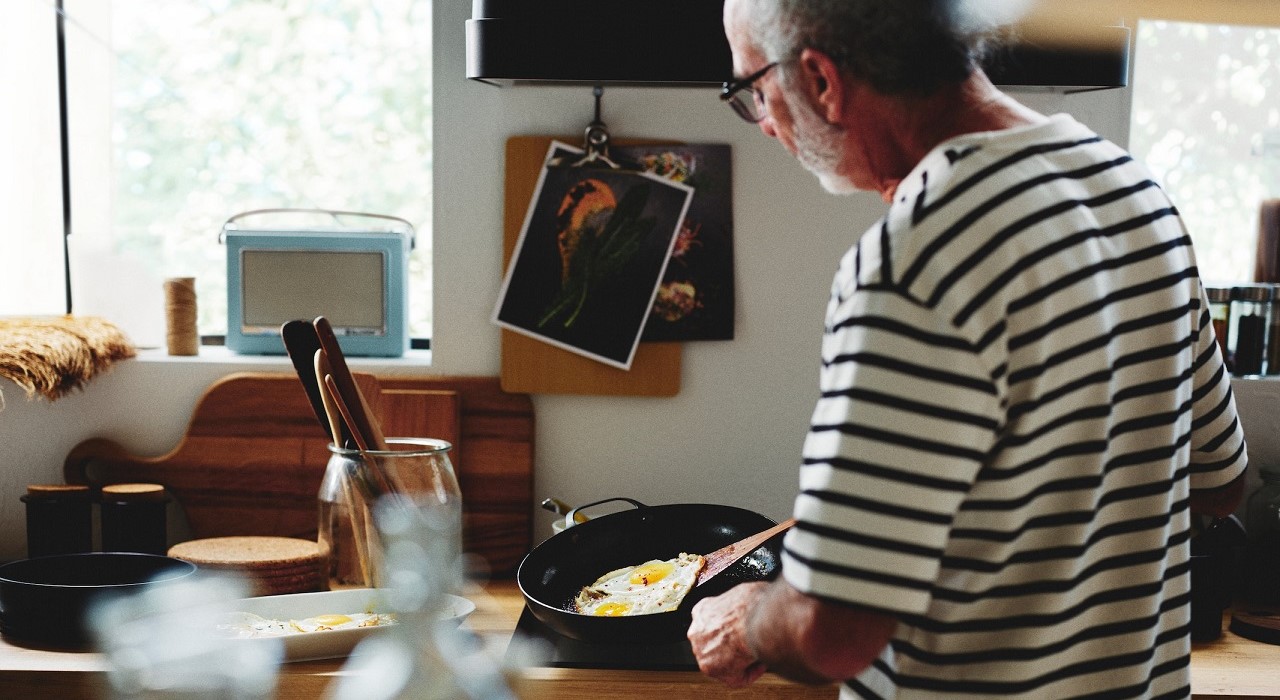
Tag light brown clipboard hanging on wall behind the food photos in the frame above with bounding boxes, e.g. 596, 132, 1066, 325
502, 136, 682, 397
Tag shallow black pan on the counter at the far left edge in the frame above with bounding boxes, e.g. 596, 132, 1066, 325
0, 552, 196, 649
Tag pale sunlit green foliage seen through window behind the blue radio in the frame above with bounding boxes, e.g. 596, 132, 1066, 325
110, 0, 433, 335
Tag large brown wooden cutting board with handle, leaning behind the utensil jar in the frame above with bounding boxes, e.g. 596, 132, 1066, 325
63, 372, 534, 576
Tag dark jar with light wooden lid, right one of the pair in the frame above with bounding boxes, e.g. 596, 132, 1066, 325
100, 484, 169, 554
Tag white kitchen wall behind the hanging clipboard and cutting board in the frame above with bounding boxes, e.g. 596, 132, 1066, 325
0, 1, 1167, 561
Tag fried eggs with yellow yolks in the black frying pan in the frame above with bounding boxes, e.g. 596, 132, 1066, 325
573, 553, 707, 617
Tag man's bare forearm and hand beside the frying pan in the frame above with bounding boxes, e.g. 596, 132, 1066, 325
689, 578, 897, 687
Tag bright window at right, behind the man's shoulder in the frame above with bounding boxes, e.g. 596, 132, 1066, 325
1130, 20, 1280, 283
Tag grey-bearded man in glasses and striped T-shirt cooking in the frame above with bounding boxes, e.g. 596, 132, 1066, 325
689, 0, 1245, 699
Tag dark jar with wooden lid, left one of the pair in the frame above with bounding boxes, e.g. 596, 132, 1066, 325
20, 484, 93, 558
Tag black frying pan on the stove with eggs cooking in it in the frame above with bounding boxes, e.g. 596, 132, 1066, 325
516, 498, 782, 644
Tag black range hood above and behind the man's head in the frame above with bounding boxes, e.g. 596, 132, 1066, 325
466, 0, 1129, 90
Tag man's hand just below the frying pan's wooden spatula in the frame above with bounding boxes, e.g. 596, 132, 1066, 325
689, 582, 768, 687
